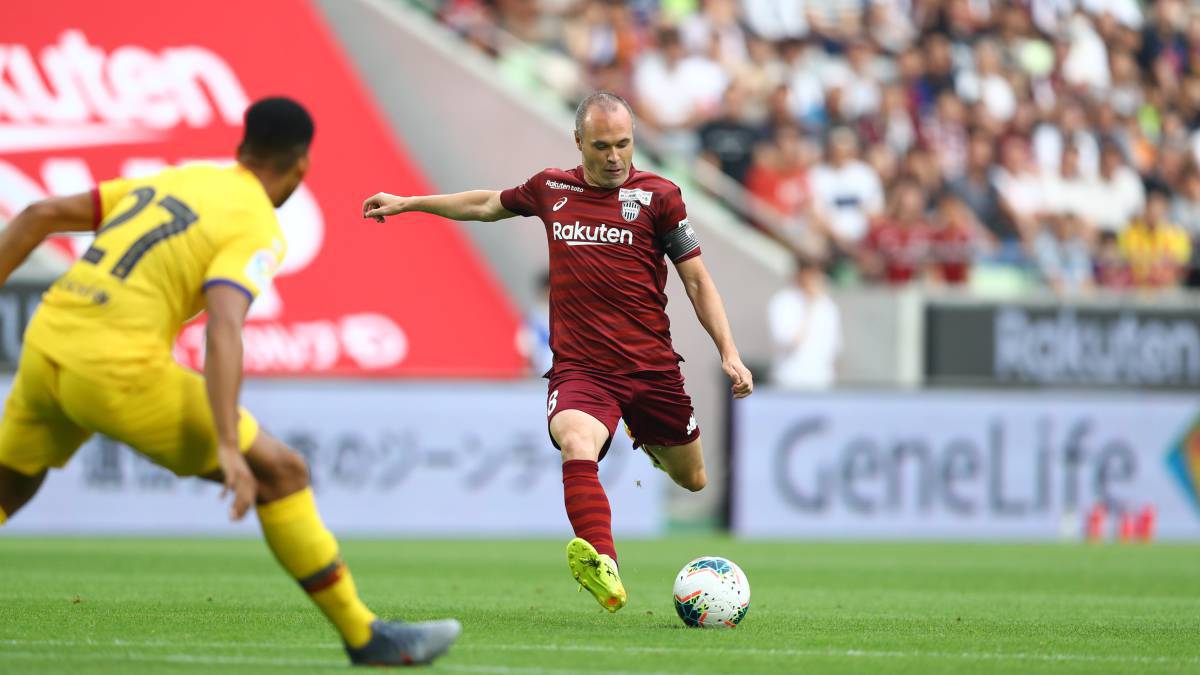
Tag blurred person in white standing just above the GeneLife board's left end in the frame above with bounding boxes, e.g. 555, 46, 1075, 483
767, 253, 841, 389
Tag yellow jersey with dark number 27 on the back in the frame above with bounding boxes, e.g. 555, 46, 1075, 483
25, 165, 286, 380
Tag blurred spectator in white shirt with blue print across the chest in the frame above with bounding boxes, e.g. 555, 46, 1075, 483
812, 127, 883, 251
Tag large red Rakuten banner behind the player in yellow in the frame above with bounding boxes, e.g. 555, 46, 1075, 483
0, 0, 522, 377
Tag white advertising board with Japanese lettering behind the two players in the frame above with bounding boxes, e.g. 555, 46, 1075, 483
0, 378, 664, 537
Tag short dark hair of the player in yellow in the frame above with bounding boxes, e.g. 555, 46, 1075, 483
238, 96, 313, 171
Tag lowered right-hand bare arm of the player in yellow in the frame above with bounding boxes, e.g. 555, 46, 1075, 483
204, 283, 258, 520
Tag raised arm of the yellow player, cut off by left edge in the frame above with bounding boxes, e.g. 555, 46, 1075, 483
0, 192, 96, 285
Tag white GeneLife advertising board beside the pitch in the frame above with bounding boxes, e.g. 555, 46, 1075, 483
732, 390, 1200, 539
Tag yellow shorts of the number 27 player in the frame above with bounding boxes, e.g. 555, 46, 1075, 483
0, 344, 258, 476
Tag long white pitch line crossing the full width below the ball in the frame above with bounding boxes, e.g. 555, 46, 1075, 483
0, 640, 1200, 673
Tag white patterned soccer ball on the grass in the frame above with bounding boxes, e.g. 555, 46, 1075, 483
674, 556, 750, 628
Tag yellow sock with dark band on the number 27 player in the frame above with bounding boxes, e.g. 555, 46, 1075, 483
258, 488, 376, 647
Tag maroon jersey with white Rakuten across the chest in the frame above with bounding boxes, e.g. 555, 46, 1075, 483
500, 166, 700, 374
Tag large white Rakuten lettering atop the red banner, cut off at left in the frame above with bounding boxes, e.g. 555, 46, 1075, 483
0, 29, 250, 153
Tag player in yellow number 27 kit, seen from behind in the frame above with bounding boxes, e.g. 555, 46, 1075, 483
0, 98, 461, 665
